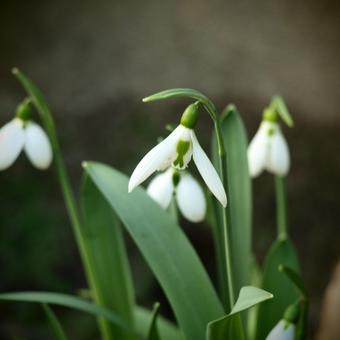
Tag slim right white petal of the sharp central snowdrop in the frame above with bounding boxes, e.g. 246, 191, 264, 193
191, 131, 227, 207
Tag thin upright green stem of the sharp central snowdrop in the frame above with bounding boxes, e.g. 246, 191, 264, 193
214, 119, 235, 310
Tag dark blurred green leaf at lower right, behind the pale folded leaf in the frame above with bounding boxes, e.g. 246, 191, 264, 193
255, 239, 299, 340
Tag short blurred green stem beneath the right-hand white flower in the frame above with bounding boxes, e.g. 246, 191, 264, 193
275, 176, 288, 240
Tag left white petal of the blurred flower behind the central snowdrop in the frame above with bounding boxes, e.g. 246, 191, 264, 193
147, 168, 174, 209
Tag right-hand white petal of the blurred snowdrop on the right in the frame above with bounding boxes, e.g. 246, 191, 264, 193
266, 126, 290, 176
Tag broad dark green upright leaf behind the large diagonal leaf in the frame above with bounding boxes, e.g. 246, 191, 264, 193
81, 175, 134, 340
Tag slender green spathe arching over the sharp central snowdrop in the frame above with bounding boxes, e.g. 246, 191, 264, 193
143, 88, 216, 117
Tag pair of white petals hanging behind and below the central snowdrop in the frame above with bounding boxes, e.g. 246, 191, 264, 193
147, 168, 207, 223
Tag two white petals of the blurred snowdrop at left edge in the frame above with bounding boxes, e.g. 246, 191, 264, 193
0, 118, 52, 170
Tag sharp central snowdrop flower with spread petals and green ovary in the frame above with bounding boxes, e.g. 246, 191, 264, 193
128, 103, 227, 207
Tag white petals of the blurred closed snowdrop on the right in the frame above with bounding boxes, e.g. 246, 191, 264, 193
248, 121, 290, 177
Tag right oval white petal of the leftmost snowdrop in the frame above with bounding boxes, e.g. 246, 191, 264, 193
25, 122, 52, 170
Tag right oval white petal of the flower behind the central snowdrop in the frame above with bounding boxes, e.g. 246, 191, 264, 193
176, 174, 207, 223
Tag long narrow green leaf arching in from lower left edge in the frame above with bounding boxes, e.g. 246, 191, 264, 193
0, 292, 133, 333
